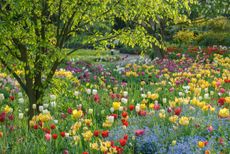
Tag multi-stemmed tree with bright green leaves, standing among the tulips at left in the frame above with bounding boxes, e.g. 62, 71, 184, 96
0, 0, 194, 118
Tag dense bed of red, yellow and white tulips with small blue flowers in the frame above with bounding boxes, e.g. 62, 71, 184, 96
0, 47, 230, 154
